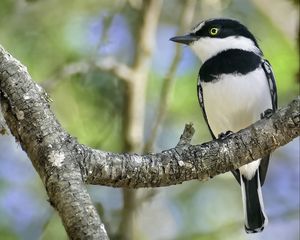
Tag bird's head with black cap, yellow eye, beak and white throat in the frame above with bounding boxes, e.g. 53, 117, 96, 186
170, 18, 262, 62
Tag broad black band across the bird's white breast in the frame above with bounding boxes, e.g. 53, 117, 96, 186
199, 49, 261, 82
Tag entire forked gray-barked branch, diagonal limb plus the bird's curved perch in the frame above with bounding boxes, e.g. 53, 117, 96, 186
0, 46, 300, 239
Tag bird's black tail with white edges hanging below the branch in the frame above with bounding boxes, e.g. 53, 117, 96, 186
240, 170, 268, 233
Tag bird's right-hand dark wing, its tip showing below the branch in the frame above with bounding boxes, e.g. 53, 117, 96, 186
259, 60, 277, 185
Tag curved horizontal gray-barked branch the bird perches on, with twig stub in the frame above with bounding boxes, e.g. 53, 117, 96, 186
78, 97, 300, 188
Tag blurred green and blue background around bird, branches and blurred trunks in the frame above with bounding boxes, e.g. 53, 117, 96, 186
0, 0, 299, 240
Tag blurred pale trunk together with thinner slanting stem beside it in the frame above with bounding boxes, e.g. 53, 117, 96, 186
118, 0, 196, 240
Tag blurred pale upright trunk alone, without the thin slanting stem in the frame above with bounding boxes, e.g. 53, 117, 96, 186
117, 0, 162, 240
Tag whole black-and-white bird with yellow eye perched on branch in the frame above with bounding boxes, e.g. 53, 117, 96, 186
170, 18, 277, 233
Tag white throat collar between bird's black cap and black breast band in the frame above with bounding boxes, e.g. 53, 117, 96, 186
190, 36, 261, 62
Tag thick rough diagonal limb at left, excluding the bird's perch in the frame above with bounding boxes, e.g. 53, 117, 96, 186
0, 45, 108, 239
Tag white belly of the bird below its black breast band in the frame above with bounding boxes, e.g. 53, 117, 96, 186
201, 68, 272, 178
